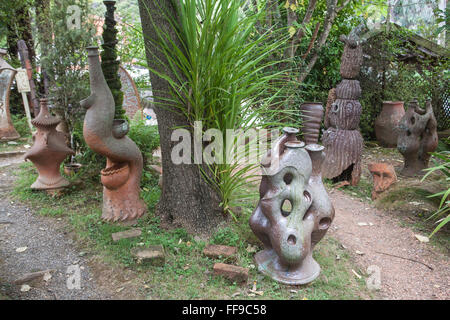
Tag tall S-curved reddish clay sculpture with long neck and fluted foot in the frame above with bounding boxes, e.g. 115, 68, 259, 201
80, 47, 146, 222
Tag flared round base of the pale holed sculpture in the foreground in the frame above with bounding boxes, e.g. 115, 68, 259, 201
255, 249, 320, 285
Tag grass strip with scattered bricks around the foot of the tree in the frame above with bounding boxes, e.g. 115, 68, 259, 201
13, 163, 370, 300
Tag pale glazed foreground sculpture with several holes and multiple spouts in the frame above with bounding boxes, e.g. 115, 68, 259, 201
249, 128, 334, 285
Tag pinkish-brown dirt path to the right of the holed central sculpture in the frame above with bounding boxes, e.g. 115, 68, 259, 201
330, 190, 450, 299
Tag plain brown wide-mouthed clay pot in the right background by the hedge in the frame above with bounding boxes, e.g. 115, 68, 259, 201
375, 101, 405, 148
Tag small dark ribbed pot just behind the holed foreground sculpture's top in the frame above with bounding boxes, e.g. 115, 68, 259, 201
300, 102, 323, 144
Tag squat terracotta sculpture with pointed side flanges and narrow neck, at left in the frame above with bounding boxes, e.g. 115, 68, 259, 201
25, 99, 75, 190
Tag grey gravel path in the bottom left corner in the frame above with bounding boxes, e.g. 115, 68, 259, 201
0, 156, 111, 300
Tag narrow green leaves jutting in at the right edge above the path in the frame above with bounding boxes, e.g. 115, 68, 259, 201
422, 139, 450, 237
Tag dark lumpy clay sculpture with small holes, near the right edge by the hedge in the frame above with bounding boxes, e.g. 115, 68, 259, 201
397, 100, 438, 176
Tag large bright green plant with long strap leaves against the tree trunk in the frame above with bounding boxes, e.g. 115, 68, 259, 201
143, 0, 298, 213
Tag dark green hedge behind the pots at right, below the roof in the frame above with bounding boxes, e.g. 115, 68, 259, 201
360, 28, 450, 140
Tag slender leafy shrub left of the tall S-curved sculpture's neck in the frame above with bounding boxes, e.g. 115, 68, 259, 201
41, 0, 95, 156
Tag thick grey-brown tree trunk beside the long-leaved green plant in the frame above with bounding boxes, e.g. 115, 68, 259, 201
135, 0, 224, 235
